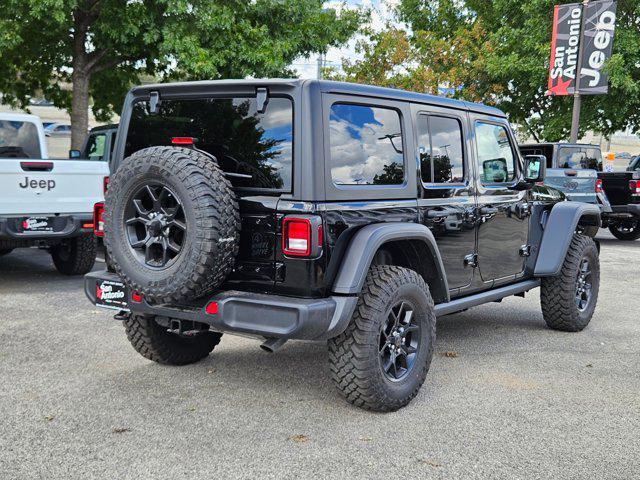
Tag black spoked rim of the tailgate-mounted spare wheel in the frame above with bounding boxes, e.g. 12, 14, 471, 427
124, 183, 187, 269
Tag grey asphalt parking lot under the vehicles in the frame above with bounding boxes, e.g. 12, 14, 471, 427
0, 233, 640, 479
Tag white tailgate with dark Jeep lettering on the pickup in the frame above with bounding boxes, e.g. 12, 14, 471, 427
0, 159, 109, 215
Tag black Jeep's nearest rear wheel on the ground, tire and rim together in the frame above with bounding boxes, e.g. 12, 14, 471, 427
328, 265, 436, 412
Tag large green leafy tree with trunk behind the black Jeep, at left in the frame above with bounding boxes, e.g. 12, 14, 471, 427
0, 0, 366, 148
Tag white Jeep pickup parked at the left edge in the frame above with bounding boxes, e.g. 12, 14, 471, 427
0, 113, 109, 275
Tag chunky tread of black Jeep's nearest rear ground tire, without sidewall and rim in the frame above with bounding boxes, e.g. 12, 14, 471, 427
328, 265, 436, 412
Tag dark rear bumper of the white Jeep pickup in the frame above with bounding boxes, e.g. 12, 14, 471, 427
0, 213, 93, 243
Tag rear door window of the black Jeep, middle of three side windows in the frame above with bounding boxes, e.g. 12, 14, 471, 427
417, 115, 464, 183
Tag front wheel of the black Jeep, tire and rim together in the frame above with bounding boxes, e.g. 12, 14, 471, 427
540, 235, 600, 332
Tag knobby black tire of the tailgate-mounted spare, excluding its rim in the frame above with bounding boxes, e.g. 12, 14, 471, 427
104, 147, 240, 303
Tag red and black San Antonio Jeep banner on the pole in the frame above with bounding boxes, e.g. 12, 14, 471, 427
547, 0, 616, 95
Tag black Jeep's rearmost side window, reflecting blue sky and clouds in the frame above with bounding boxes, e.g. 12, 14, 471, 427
329, 103, 404, 185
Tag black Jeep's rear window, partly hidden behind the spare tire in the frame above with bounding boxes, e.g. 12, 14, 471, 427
125, 97, 293, 191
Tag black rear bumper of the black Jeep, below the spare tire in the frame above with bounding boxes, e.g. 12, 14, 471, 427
85, 271, 358, 340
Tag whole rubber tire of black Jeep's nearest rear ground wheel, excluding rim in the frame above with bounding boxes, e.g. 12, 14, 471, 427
328, 265, 436, 412
